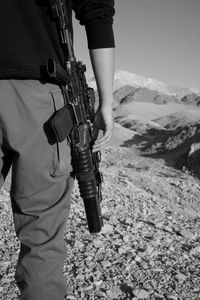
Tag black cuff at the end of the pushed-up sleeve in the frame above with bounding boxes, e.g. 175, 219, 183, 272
85, 23, 115, 49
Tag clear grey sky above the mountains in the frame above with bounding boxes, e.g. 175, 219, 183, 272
74, 0, 200, 90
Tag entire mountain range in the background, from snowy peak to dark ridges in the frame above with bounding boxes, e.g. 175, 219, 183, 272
89, 71, 200, 179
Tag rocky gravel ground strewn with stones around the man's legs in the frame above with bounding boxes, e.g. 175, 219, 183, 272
0, 147, 200, 300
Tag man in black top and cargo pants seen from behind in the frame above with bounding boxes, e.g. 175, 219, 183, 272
0, 0, 114, 300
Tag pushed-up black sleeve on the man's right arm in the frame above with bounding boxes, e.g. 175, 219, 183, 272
72, 0, 115, 49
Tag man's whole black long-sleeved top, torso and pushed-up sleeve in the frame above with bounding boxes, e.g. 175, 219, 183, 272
0, 0, 114, 79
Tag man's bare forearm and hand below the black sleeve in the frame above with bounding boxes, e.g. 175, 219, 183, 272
90, 48, 114, 152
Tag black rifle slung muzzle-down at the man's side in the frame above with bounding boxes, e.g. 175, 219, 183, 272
46, 0, 103, 233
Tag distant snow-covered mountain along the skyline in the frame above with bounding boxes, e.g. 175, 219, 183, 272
88, 70, 200, 99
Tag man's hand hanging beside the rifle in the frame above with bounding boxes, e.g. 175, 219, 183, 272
92, 105, 114, 152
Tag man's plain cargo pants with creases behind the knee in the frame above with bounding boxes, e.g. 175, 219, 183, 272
0, 80, 74, 300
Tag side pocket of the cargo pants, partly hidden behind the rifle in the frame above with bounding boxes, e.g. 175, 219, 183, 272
50, 88, 72, 177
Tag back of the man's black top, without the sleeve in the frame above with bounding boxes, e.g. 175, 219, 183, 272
0, 0, 66, 79
